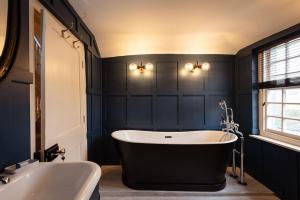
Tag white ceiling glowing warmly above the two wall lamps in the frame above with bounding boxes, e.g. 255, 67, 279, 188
69, 0, 300, 57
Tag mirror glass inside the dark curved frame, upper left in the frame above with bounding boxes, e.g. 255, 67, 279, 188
0, 0, 8, 57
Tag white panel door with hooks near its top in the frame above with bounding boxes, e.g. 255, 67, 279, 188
42, 11, 87, 161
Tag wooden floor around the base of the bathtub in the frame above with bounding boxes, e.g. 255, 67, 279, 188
100, 166, 278, 200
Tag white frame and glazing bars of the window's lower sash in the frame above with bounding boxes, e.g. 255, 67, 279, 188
259, 86, 300, 147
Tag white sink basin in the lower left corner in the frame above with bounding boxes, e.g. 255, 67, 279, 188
0, 161, 101, 200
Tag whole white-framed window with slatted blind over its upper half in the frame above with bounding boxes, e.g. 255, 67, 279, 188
258, 34, 300, 145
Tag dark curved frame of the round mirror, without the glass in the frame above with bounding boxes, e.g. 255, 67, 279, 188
0, 0, 20, 81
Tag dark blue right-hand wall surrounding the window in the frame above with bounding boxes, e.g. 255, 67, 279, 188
235, 24, 300, 200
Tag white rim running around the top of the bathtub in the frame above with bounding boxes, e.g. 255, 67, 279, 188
111, 129, 238, 145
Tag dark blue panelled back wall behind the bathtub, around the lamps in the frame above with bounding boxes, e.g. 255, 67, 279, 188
99, 55, 234, 164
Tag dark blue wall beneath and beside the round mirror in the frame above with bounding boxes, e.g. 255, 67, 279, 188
0, 0, 32, 171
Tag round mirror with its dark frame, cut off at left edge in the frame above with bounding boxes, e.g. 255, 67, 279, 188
0, 0, 20, 81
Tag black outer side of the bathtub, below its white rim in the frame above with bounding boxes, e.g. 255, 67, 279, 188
114, 139, 234, 191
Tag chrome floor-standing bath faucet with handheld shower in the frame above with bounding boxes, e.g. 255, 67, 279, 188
219, 100, 247, 185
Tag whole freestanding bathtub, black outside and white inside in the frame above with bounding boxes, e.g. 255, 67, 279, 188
112, 130, 237, 191
